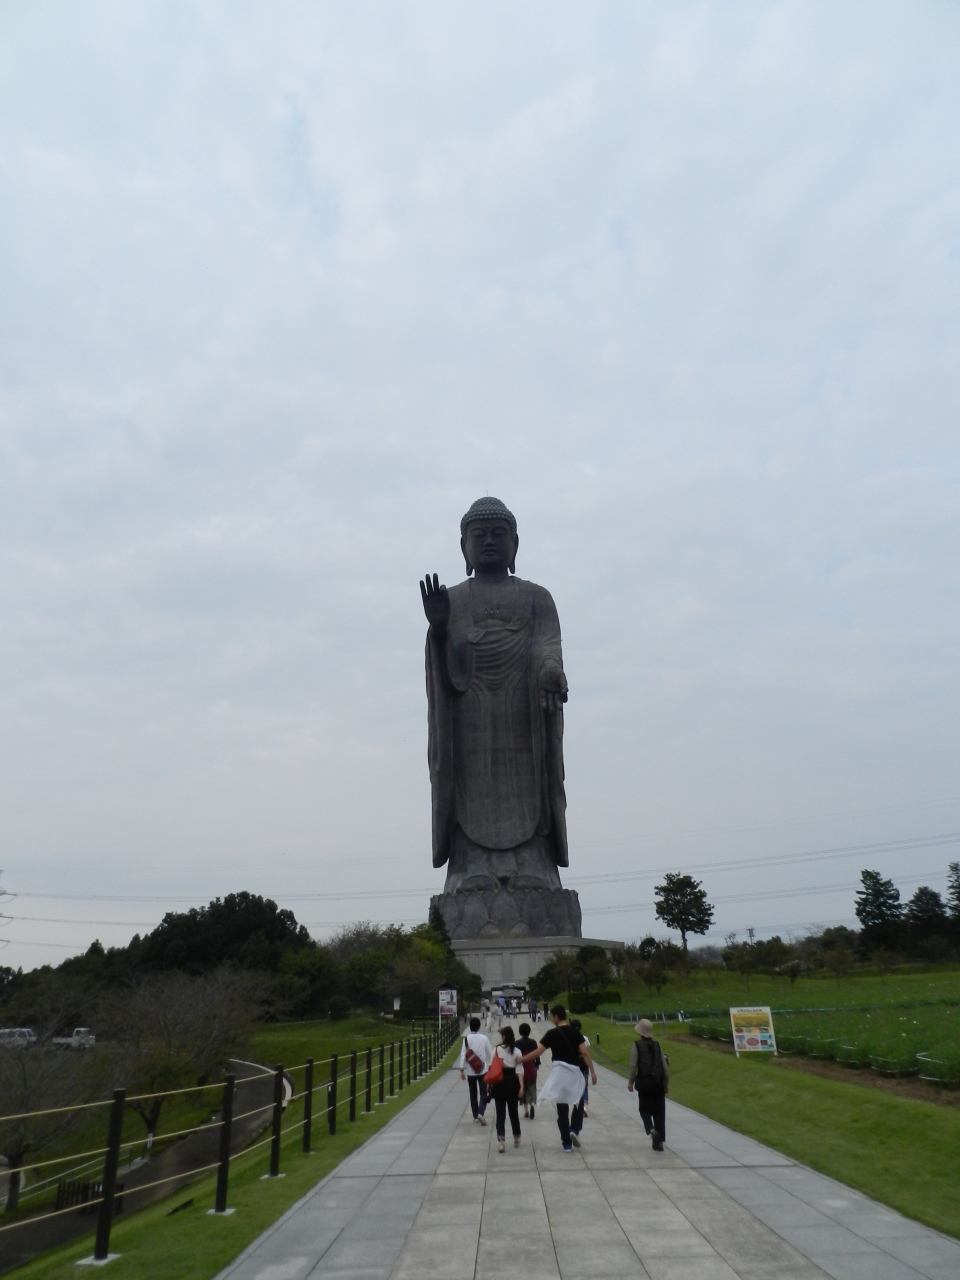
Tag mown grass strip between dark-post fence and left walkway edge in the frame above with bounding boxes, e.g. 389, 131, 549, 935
15, 1039, 460, 1280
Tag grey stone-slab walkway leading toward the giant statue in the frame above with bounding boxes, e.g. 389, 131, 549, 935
218, 1049, 960, 1280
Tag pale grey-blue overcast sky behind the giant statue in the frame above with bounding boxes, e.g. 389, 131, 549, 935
0, 0, 960, 968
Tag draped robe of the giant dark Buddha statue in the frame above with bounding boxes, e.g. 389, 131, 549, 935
426, 577, 567, 867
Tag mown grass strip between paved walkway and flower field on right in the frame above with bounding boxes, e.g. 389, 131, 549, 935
581, 1015, 960, 1236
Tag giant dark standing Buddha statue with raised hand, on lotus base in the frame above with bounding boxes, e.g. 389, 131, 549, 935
420, 498, 580, 938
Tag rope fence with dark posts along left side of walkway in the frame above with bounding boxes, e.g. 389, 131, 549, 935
0, 1019, 460, 1262
